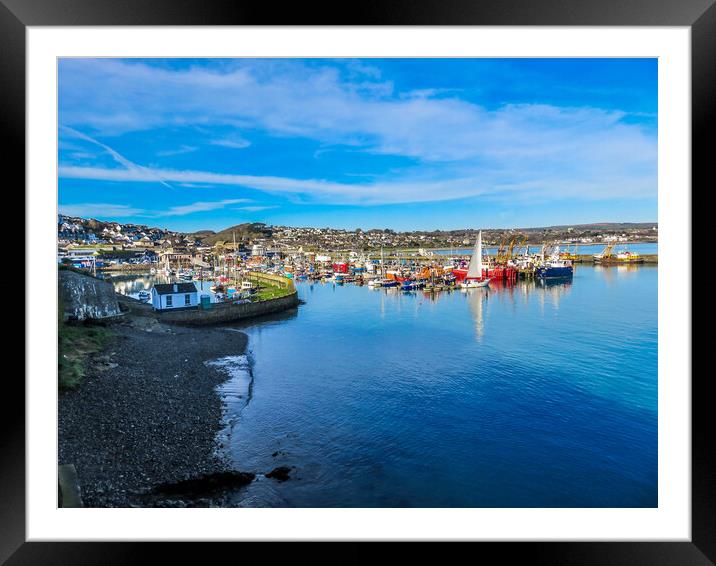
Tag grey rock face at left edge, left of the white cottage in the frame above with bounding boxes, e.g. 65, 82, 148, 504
58, 269, 121, 320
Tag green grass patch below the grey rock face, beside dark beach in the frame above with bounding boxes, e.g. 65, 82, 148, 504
57, 321, 112, 390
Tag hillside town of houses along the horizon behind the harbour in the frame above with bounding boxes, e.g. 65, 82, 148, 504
57, 215, 658, 262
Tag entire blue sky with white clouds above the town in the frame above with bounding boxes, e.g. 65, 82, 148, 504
58, 59, 657, 231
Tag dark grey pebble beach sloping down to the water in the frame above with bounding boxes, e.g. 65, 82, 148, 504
58, 317, 254, 507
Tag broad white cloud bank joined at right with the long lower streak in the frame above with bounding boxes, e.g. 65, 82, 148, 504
60, 59, 657, 204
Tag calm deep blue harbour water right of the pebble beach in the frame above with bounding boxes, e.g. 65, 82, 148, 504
220, 265, 658, 507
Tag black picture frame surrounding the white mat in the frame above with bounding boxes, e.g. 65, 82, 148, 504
0, 0, 716, 565
